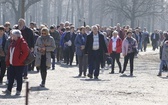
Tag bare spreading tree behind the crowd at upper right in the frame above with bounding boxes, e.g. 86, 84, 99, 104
105, 0, 163, 27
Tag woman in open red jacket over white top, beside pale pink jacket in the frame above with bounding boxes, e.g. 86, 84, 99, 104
108, 31, 122, 74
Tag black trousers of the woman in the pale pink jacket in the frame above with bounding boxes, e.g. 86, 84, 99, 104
123, 53, 134, 74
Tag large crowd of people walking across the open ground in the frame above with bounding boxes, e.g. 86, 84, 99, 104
0, 19, 168, 95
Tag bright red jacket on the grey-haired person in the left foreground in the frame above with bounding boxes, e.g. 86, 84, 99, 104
6, 38, 29, 66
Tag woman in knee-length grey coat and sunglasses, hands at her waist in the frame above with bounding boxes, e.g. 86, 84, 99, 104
35, 28, 56, 87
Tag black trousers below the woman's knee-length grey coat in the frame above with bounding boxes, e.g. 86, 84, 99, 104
40, 55, 47, 84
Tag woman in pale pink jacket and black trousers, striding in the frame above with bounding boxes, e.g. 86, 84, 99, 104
121, 31, 137, 76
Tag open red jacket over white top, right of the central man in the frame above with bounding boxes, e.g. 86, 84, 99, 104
108, 37, 122, 54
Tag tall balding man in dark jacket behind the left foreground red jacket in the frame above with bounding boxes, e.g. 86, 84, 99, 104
17, 19, 34, 79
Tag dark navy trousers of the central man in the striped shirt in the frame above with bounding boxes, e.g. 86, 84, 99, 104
88, 50, 100, 77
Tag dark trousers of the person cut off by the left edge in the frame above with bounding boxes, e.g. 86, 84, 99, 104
0, 59, 6, 82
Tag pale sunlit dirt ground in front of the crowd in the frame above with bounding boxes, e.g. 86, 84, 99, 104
0, 49, 168, 105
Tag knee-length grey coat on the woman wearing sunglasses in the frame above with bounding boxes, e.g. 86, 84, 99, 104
34, 35, 56, 67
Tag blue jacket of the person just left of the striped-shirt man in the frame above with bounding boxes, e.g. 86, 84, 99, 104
75, 34, 87, 56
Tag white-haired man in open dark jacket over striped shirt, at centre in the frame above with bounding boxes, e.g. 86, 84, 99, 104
85, 26, 107, 79
